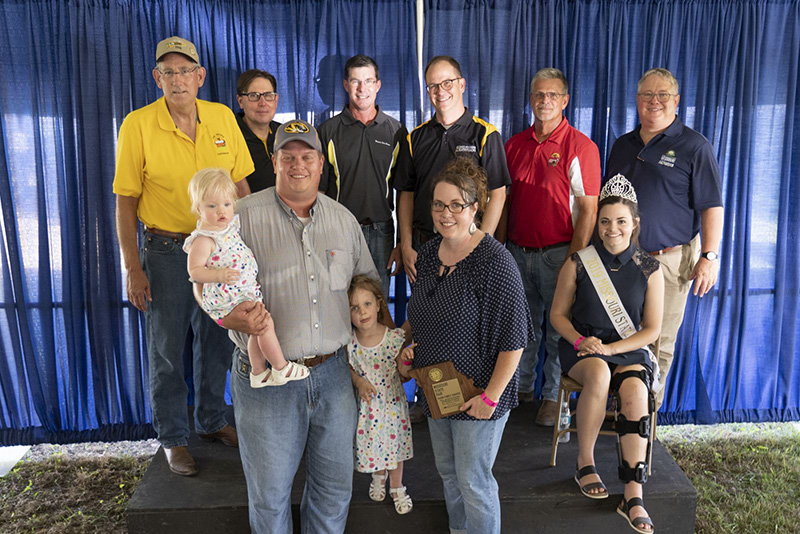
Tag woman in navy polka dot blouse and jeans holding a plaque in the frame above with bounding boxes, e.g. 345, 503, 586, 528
400, 157, 533, 534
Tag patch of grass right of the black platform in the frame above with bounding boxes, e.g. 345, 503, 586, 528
658, 423, 800, 534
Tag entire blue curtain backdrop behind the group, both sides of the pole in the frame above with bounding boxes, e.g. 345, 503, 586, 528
0, 0, 800, 444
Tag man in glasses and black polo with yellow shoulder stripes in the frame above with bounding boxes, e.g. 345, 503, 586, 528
394, 56, 511, 282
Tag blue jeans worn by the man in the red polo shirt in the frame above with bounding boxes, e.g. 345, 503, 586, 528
506, 241, 569, 401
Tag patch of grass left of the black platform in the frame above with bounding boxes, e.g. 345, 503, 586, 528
0, 455, 150, 534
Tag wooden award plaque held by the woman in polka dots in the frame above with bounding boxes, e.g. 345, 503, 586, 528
408, 360, 483, 419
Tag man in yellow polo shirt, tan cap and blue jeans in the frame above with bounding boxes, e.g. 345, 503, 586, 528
114, 37, 253, 475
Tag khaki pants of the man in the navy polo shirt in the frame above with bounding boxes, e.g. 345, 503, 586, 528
650, 235, 700, 407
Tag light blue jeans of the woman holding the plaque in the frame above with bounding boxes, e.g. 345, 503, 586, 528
428, 412, 508, 534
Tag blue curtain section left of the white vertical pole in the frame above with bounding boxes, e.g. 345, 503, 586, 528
0, 0, 420, 444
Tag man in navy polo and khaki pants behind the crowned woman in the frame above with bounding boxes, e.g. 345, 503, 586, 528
605, 69, 723, 405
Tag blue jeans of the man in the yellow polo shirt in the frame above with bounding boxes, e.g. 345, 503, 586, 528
139, 232, 233, 449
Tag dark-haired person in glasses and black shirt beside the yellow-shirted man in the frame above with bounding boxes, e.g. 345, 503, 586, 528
236, 69, 280, 193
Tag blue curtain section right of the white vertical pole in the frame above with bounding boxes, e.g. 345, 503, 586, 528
424, 0, 800, 423
